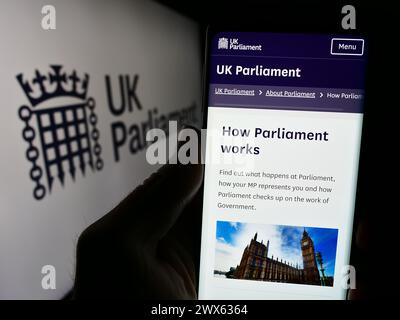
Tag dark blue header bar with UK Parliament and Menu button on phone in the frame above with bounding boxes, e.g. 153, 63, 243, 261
210, 32, 366, 89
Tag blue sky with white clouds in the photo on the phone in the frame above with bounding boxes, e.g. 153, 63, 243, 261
215, 221, 338, 276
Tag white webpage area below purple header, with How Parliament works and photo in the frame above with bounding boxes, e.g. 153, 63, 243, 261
199, 106, 362, 299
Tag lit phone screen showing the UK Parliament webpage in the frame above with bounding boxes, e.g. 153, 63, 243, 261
199, 31, 366, 299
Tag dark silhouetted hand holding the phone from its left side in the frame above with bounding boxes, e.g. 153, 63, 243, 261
73, 164, 203, 299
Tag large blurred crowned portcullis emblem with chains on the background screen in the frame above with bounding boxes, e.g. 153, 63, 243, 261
16, 65, 103, 200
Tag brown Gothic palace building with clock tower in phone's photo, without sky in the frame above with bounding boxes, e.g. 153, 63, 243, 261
230, 229, 333, 286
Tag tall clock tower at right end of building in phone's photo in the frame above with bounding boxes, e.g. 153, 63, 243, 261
301, 228, 321, 285
